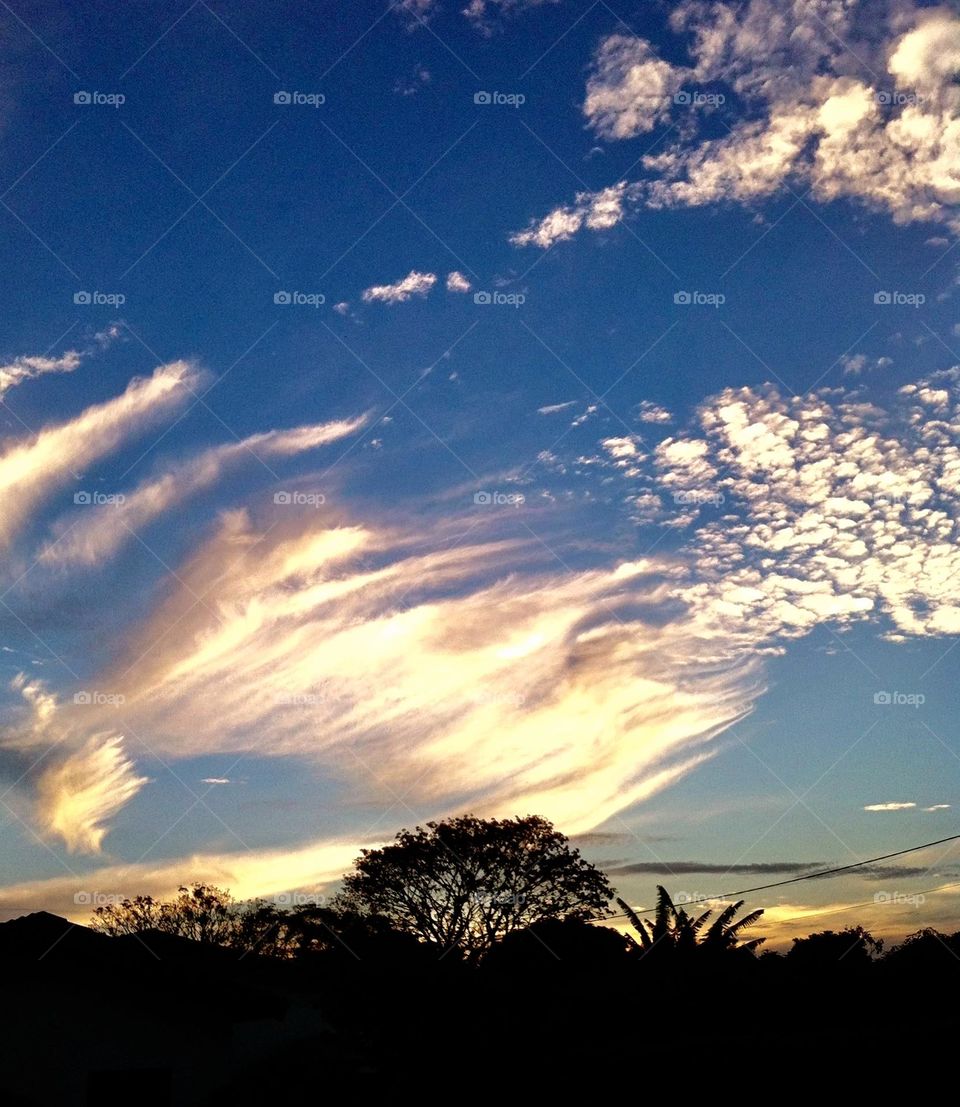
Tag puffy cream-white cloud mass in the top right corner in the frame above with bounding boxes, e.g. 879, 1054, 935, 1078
510, 0, 960, 248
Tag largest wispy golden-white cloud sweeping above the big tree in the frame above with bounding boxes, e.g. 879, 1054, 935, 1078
13, 513, 758, 845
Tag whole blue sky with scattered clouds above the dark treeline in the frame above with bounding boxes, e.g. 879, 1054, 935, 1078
0, 0, 960, 942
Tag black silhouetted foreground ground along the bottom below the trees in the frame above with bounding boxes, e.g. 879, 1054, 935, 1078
0, 914, 960, 1107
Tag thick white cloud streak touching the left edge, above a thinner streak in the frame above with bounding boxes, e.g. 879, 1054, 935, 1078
0, 361, 203, 547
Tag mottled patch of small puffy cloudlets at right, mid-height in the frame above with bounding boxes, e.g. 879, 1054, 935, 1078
566, 369, 960, 650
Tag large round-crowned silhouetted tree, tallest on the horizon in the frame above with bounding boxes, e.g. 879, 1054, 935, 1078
333, 815, 613, 959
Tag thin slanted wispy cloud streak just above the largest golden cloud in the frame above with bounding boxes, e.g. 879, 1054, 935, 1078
40, 416, 367, 566
